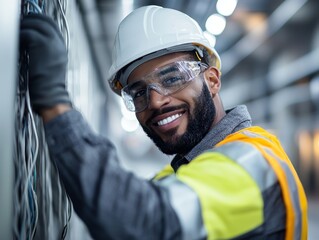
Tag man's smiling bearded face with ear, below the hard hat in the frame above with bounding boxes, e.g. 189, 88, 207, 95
129, 52, 225, 154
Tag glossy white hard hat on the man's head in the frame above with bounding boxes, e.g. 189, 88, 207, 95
108, 5, 221, 95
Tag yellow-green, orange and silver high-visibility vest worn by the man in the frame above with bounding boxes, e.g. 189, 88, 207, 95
154, 127, 308, 240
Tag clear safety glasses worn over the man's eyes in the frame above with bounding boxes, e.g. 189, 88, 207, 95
121, 61, 208, 112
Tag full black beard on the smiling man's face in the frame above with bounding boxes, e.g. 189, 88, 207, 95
142, 84, 216, 155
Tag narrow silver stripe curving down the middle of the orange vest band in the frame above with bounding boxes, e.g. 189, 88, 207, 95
264, 147, 302, 240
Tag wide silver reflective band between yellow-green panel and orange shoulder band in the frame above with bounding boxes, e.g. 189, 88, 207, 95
214, 141, 277, 192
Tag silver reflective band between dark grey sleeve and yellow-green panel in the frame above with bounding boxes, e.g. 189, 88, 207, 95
157, 175, 207, 240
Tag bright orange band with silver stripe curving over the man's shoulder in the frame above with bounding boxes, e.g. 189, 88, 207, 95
217, 127, 307, 240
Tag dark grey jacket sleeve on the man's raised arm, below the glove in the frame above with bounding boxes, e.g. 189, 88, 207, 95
45, 110, 181, 240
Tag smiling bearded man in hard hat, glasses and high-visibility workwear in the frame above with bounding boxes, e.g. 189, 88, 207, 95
21, 6, 307, 239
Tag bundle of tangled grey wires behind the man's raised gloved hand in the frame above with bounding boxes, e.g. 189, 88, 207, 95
13, 0, 72, 240
